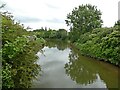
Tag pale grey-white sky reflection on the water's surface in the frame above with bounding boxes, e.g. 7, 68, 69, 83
33, 47, 106, 88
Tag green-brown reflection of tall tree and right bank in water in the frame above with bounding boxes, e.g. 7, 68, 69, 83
64, 47, 120, 88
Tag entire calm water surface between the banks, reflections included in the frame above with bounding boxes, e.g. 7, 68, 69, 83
32, 41, 118, 88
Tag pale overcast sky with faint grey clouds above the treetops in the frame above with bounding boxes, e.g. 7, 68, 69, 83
0, 0, 120, 30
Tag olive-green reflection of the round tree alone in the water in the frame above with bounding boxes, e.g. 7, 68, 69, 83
65, 51, 97, 85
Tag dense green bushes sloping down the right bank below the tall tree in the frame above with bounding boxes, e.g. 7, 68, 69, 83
76, 27, 120, 65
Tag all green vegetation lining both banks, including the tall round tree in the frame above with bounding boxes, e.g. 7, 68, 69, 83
0, 4, 120, 89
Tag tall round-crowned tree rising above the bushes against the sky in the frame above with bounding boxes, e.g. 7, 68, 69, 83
65, 4, 102, 40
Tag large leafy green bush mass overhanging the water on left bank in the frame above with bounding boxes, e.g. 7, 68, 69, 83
1, 12, 45, 89
